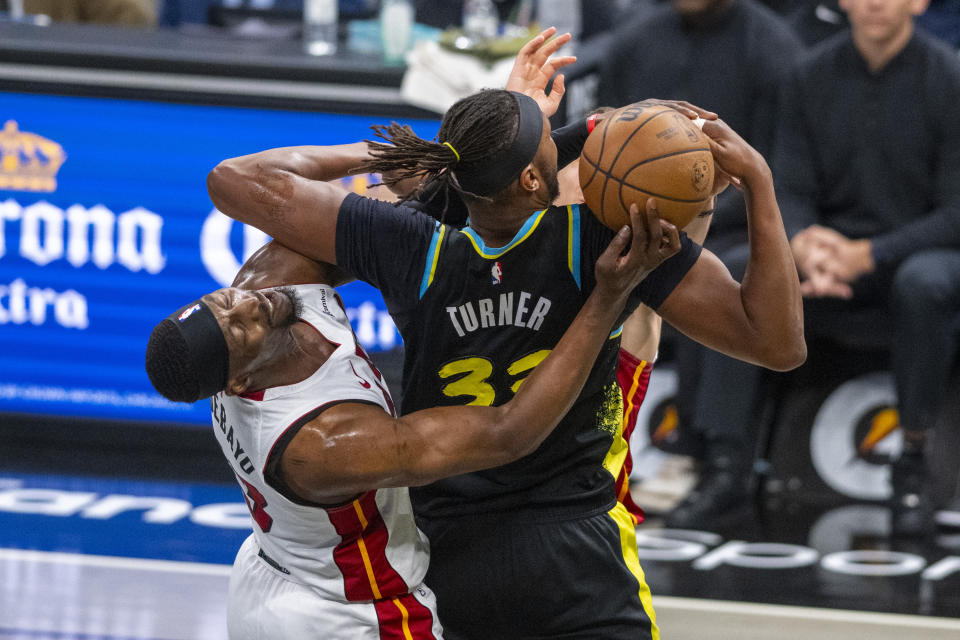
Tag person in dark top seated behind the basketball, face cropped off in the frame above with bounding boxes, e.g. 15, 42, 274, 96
597, 0, 802, 528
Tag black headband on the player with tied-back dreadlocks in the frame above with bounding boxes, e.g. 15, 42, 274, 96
454, 91, 543, 196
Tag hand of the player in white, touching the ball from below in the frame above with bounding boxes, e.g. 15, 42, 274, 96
594, 198, 680, 299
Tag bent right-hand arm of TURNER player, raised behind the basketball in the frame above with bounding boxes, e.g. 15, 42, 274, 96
658, 120, 807, 370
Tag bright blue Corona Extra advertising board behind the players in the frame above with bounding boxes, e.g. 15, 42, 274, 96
0, 93, 438, 424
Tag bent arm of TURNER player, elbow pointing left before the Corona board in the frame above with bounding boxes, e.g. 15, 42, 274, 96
207, 142, 368, 264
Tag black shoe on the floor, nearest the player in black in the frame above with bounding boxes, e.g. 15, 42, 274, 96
663, 458, 751, 529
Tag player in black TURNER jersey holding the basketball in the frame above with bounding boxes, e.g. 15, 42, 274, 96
208, 36, 806, 639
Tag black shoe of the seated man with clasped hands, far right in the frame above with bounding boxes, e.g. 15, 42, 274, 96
890, 453, 934, 538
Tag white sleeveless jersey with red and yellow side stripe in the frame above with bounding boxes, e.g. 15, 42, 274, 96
211, 285, 435, 616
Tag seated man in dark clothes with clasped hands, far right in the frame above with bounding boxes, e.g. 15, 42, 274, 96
688, 0, 960, 535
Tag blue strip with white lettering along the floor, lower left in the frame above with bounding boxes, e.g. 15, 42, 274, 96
0, 470, 252, 564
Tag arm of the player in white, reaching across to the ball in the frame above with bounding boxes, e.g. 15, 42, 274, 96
281, 199, 680, 503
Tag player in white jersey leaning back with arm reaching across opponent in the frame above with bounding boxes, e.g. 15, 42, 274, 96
146, 200, 680, 640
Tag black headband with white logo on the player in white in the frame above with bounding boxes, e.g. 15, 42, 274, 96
167, 300, 230, 398
